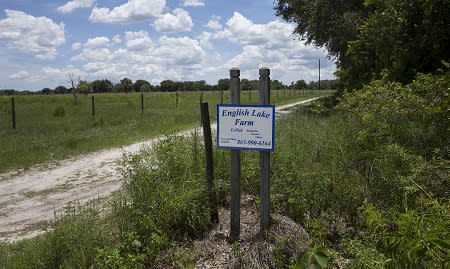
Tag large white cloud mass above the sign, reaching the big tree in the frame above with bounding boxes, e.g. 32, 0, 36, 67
207, 12, 335, 81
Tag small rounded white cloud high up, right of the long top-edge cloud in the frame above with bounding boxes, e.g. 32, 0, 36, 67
153, 8, 194, 32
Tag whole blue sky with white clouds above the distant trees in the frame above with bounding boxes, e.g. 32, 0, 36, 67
0, 0, 336, 90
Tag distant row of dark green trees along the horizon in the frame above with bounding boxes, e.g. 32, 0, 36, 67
0, 75, 338, 95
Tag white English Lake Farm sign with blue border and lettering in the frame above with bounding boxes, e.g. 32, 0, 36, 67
217, 105, 275, 151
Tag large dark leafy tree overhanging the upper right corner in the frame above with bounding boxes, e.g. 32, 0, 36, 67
275, 0, 450, 88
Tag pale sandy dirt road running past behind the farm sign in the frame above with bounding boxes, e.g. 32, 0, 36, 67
0, 98, 317, 242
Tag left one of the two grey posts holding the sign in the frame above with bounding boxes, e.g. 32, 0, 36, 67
230, 68, 241, 242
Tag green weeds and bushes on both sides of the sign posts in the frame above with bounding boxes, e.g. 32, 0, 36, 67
0, 70, 450, 268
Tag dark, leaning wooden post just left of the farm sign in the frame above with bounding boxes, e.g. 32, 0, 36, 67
200, 102, 219, 223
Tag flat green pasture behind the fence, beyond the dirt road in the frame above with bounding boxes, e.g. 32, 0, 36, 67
0, 91, 326, 172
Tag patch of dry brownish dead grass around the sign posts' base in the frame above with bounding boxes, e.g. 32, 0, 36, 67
193, 195, 310, 268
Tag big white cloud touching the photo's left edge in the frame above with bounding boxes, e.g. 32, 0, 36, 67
0, 9, 66, 59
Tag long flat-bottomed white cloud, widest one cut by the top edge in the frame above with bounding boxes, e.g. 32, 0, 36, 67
89, 0, 166, 23
